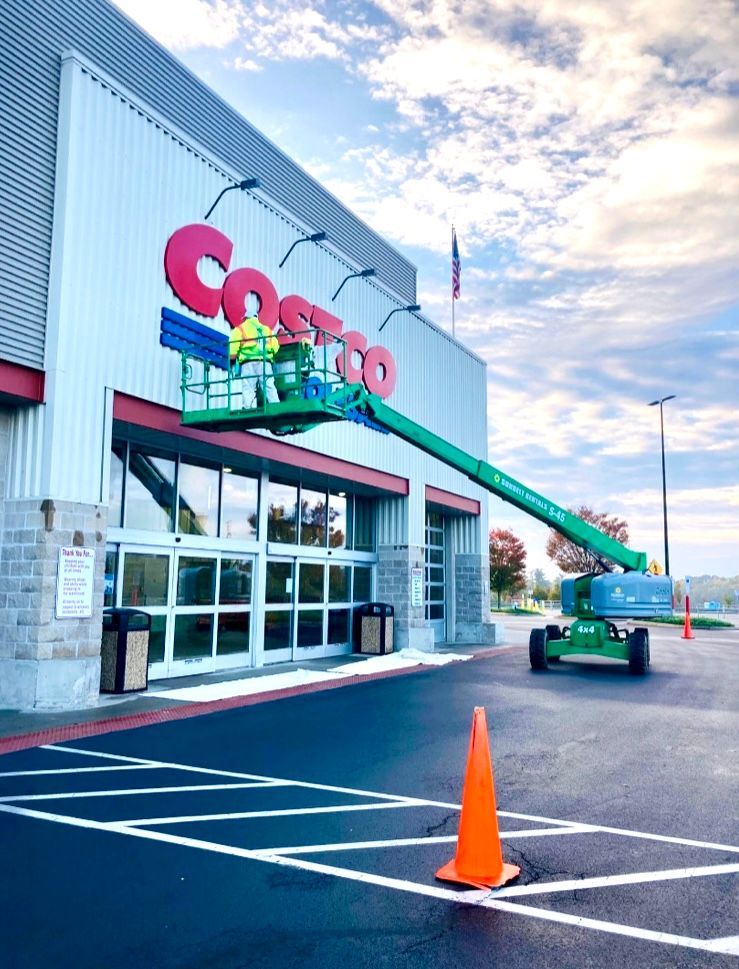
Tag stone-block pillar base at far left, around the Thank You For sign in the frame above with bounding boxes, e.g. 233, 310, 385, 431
0, 488, 107, 710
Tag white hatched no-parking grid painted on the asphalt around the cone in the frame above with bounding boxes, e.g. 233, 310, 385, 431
0, 745, 739, 955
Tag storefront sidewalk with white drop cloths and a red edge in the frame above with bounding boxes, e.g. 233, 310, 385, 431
0, 643, 511, 754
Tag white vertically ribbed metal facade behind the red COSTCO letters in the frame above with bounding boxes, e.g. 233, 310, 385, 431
23, 57, 487, 524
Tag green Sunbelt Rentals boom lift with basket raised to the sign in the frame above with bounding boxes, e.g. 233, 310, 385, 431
181, 331, 672, 674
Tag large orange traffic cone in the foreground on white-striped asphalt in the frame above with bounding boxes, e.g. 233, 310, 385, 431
436, 707, 521, 888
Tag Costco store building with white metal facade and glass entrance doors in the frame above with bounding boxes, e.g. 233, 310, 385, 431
0, 0, 494, 709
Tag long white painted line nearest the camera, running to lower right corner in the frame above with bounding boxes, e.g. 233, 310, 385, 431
0, 804, 735, 955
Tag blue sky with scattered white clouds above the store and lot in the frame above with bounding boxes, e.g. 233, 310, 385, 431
112, 0, 739, 578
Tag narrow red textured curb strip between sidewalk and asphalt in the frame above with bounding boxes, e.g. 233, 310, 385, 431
0, 646, 520, 755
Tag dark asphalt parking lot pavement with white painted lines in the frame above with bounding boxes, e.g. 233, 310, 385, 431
0, 618, 739, 969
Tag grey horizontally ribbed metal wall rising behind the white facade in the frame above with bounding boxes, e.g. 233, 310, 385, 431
0, 0, 416, 367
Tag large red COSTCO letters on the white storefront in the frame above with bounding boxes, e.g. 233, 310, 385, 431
164, 223, 397, 397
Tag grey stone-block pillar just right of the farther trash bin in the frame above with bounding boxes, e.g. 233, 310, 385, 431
375, 545, 434, 649
